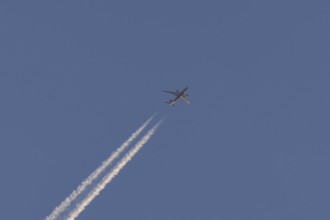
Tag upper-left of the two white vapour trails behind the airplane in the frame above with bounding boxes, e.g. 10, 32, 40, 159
46, 115, 154, 220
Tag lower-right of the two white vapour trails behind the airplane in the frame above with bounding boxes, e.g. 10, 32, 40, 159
66, 121, 162, 220
